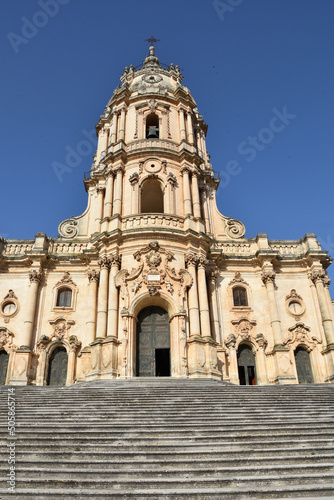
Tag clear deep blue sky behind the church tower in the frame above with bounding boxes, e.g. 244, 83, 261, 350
0, 0, 334, 293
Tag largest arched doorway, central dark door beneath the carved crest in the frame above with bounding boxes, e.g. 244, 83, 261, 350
136, 306, 170, 377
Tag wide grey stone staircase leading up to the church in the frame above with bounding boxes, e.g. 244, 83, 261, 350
0, 378, 334, 500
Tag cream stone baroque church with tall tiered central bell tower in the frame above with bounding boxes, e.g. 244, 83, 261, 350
0, 46, 334, 385
